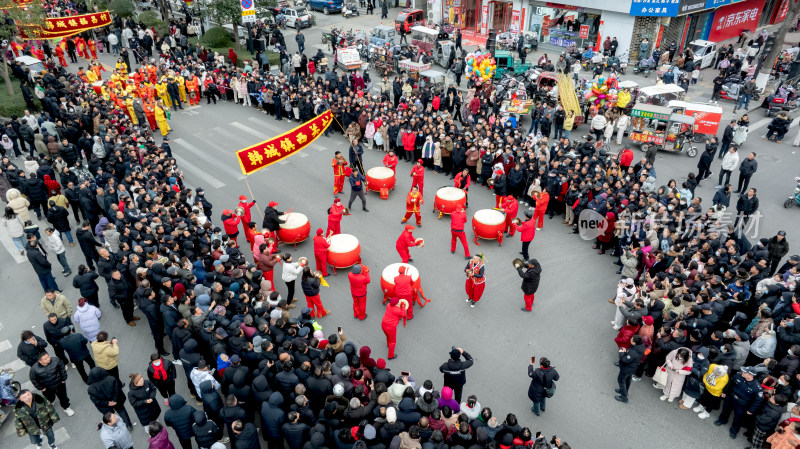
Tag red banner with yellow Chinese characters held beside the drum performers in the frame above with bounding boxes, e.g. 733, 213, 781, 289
236, 111, 333, 175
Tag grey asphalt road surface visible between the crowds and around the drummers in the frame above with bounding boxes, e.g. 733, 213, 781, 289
0, 9, 800, 449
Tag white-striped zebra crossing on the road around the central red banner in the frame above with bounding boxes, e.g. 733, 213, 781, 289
170, 116, 329, 189
